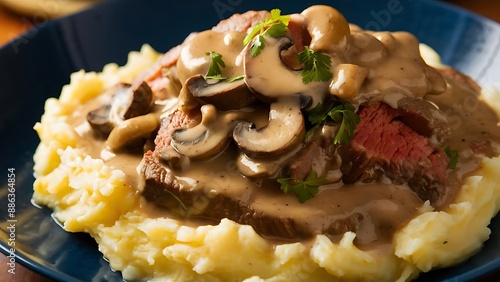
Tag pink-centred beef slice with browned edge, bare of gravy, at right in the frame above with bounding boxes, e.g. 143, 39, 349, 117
340, 102, 449, 203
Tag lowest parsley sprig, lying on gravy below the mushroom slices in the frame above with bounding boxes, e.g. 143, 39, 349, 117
278, 170, 325, 203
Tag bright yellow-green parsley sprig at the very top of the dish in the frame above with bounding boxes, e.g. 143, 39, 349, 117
243, 9, 290, 57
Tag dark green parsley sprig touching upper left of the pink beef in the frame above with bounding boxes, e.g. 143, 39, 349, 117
307, 100, 360, 144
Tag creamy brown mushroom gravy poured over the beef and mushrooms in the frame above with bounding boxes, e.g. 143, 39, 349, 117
71, 6, 500, 248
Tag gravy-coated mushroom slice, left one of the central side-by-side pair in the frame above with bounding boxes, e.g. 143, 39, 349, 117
171, 104, 243, 160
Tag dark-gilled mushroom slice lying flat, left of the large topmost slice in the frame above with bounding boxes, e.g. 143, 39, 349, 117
185, 75, 255, 111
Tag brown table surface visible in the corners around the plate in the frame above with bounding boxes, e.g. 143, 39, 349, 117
0, 0, 500, 282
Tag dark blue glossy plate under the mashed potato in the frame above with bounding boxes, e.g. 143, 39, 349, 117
0, 0, 500, 281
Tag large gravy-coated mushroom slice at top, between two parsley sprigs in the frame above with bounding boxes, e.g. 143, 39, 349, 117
244, 36, 328, 105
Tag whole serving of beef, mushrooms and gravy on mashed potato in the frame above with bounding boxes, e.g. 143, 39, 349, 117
33, 6, 500, 281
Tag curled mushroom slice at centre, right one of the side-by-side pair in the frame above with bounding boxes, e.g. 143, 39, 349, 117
233, 97, 305, 158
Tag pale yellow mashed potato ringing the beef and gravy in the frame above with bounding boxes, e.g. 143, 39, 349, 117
33, 42, 500, 281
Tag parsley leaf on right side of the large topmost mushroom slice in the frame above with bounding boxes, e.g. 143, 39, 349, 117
297, 46, 332, 84
